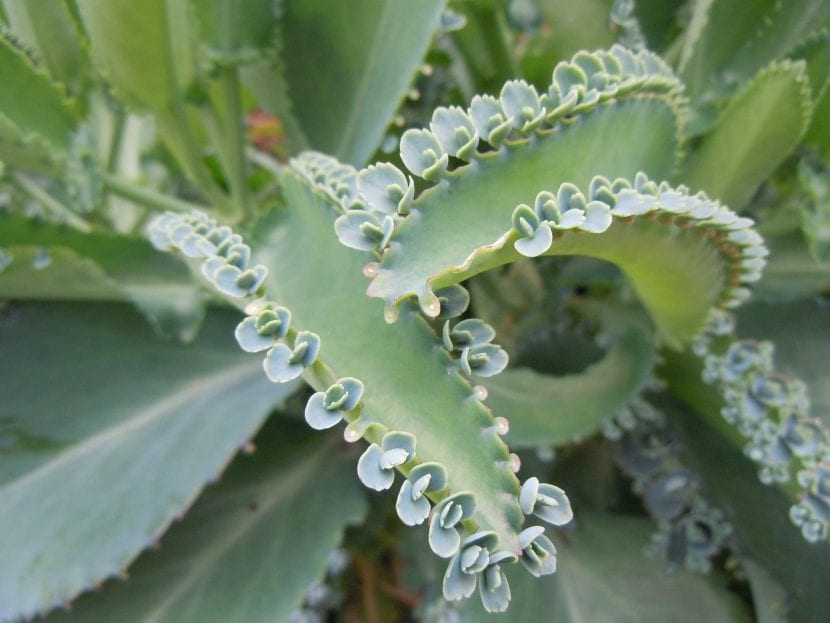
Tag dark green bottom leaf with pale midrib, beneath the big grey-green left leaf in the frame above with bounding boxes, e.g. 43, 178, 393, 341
39, 420, 366, 623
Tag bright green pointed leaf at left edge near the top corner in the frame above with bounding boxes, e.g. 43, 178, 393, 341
0, 31, 75, 153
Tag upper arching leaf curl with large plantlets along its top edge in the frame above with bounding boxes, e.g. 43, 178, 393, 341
360, 45, 685, 322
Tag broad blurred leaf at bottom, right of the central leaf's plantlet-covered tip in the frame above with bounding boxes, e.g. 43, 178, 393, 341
462, 512, 746, 623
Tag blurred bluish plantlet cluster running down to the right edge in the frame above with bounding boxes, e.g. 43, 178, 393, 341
680, 310, 830, 543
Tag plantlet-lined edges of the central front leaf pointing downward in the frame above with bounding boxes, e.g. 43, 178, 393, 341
150, 182, 571, 611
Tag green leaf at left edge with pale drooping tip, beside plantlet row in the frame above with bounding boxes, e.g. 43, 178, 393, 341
0, 214, 204, 340
